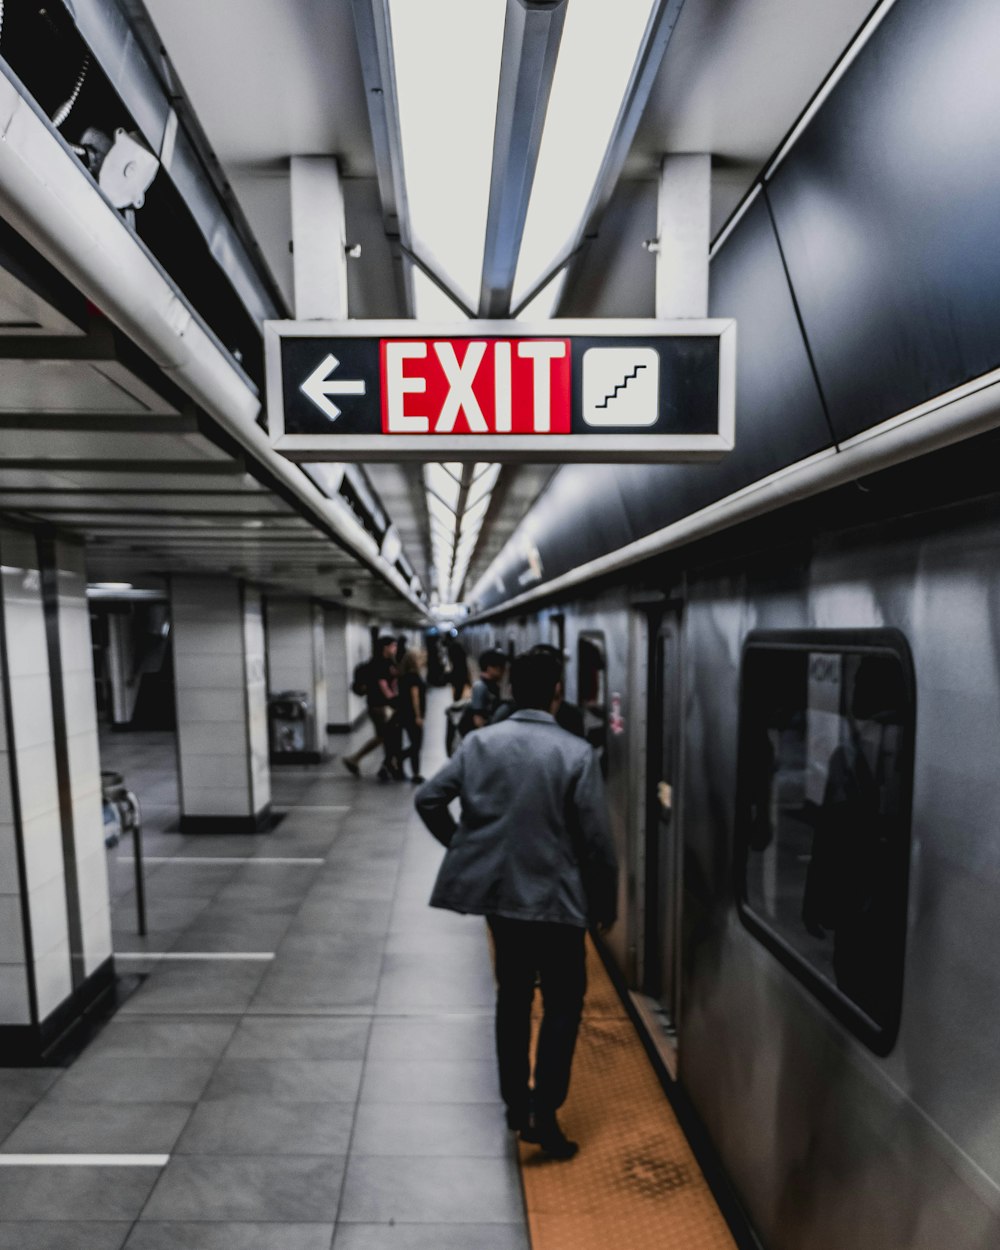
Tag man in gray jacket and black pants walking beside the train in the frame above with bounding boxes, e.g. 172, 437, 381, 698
415, 654, 618, 1159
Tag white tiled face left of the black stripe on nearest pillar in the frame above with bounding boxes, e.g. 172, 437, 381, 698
0, 528, 73, 1024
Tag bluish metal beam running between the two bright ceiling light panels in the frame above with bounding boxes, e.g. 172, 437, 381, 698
479, 0, 566, 318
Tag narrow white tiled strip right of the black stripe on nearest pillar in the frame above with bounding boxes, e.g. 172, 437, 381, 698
54, 543, 111, 976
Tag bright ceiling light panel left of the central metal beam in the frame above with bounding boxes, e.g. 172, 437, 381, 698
389, 0, 506, 320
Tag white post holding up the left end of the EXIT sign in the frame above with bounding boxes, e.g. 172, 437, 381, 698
291, 156, 348, 321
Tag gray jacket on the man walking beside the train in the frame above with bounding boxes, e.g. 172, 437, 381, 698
415, 709, 618, 926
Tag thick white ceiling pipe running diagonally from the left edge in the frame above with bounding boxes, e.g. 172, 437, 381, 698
0, 66, 424, 611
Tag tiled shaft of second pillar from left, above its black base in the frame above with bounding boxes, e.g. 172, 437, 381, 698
176, 578, 266, 816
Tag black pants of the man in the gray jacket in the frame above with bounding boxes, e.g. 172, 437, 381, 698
488, 916, 586, 1118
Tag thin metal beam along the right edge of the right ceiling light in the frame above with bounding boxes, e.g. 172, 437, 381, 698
546, 0, 684, 316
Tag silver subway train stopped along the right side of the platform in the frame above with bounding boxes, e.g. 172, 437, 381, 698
466, 425, 1000, 1250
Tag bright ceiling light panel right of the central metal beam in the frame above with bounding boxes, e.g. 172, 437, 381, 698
514, 0, 653, 316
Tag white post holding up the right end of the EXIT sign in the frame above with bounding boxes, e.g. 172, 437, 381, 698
656, 153, 711, 318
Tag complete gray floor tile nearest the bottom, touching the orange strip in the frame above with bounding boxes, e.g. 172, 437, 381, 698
340, 1155, 524, 1224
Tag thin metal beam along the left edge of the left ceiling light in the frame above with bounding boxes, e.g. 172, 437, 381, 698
351, 0, 415, 316
